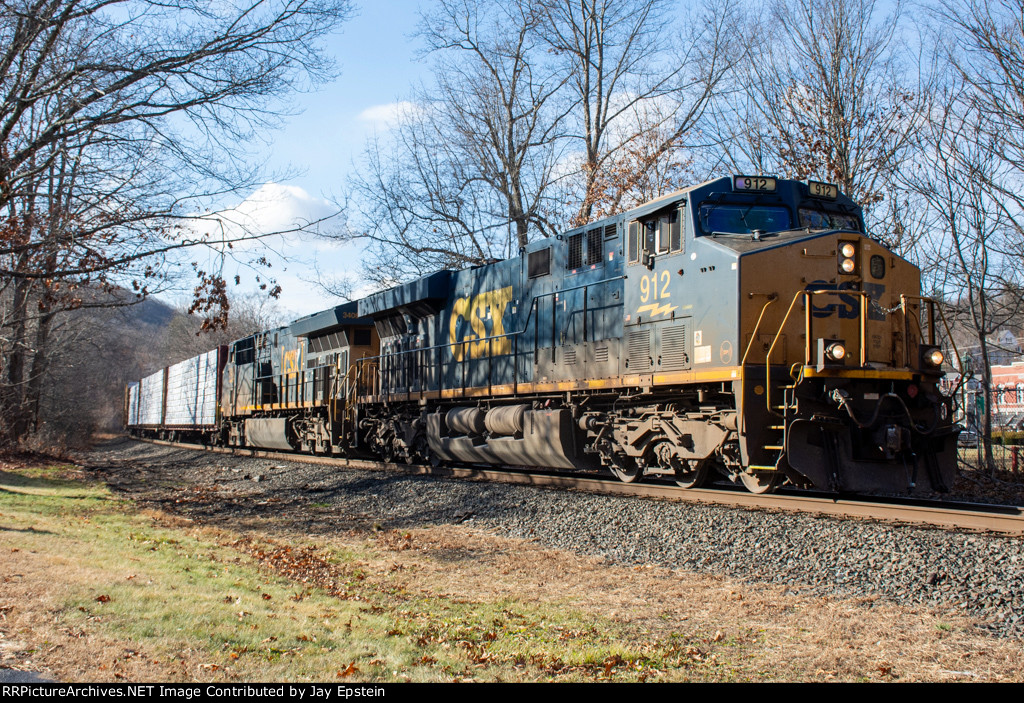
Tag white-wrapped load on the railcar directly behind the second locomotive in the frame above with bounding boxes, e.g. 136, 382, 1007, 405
164, 348, 222, 429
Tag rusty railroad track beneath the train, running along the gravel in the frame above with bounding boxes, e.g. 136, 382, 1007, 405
140, 439, 1024, 535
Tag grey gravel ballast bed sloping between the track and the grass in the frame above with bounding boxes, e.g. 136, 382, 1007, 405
80, 440, 1024, 638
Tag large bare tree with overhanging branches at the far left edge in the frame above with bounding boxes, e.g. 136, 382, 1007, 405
0, 0, 349, 443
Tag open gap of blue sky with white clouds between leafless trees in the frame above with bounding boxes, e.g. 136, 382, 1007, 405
186, 0, 429, 317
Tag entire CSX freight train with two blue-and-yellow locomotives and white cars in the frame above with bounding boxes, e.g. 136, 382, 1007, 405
125, 176, 958, 493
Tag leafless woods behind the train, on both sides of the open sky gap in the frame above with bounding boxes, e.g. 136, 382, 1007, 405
0, 0, 1024, 472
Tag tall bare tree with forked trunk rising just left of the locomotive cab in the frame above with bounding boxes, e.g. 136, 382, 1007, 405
539, 0, 743, 224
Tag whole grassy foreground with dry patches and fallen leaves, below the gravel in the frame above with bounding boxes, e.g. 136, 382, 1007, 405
0, 460, 1024, 682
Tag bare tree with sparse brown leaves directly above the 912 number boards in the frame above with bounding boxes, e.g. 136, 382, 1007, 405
716, 0, 929, 249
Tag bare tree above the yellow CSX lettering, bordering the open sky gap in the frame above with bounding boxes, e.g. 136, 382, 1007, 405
355, 0, 564, 282
